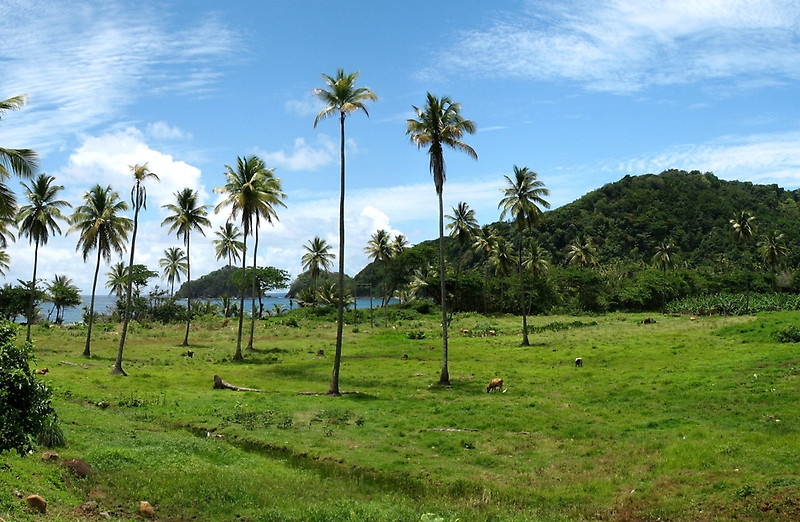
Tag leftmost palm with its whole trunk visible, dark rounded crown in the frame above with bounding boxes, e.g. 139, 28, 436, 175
18, 174, 72, 341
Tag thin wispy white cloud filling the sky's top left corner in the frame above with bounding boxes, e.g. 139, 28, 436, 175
0, 0, 235, 154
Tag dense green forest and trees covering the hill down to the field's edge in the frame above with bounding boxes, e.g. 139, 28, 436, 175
338, 170, 800, 314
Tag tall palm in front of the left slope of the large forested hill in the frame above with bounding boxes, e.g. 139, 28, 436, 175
498, 165, 550, 346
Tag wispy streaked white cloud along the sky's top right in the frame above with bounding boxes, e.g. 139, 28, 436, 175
428, 0, 800, 93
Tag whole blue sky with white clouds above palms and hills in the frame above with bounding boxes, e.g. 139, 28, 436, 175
0, 0, 800, 291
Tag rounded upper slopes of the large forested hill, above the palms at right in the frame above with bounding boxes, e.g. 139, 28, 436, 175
528, 170, 800, 267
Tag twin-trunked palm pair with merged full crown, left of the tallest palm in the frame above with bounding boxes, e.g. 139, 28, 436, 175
214, 152, 286, 361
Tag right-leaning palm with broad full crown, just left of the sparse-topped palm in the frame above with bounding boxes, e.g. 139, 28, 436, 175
69, 185, 133, 357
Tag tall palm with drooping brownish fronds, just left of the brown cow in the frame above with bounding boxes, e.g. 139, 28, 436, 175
406, 93, 478, 386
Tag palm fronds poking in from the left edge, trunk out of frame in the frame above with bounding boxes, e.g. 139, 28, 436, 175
0, 94, 39, 247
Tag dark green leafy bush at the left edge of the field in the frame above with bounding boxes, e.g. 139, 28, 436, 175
0, 322, 55, 455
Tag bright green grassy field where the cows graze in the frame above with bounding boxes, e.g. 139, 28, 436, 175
0, 312, 800, 521
